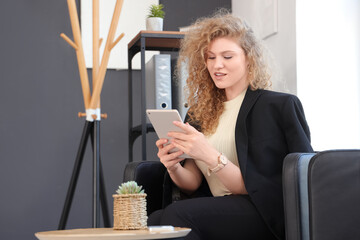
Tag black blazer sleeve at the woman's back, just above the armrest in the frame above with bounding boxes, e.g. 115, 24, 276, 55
282, 95, 313, 152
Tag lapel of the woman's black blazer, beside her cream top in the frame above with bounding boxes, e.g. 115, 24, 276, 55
235, 87, 262, 180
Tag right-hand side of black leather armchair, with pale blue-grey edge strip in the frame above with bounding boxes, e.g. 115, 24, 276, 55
283, 150, 360, 240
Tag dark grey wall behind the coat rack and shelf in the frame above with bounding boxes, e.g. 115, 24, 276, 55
0, 0, 230, 240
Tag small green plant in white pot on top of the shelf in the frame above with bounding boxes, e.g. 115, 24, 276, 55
146, 4, 165, 31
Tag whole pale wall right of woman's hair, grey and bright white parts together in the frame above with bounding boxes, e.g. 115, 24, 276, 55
232, 0, 360, 151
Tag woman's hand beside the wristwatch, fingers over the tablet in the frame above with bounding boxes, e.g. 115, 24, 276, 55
168, 121, 220, 166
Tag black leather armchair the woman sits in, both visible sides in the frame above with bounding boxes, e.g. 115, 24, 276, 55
124, 150, 360, 240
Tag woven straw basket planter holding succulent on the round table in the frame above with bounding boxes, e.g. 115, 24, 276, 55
113, 193, 147, 230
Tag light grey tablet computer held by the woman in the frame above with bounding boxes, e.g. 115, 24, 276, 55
146, 109, 190, 158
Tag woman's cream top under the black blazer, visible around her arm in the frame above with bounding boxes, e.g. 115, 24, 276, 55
195, 90, 246, 196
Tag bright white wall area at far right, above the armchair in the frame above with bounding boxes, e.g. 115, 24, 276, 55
296, 0, 360, 150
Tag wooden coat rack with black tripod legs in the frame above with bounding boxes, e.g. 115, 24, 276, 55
58, 0, 124, 230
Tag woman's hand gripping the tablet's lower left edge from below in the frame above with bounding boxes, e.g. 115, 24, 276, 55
156, 138, 184, 173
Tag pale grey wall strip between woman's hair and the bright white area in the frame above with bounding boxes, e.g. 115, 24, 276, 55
231, 0, 297, 94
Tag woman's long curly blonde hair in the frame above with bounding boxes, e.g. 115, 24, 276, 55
177, 10, 271, 135
